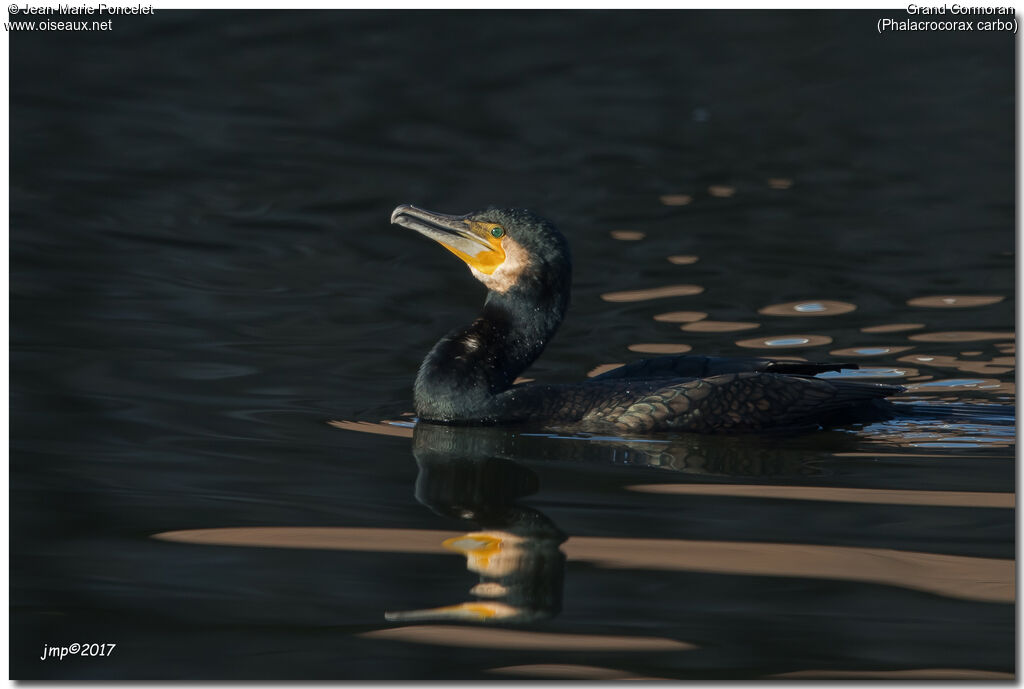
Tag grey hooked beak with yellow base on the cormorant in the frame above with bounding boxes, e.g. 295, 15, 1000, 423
391, 205, 505, 274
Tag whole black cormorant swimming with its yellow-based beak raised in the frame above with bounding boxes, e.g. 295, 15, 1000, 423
391, 206, 903, 433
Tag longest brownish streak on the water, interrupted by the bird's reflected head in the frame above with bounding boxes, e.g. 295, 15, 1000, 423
153, 526, 1016, 601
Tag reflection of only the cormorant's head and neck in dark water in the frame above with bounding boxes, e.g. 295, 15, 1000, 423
385, 424, 566, 622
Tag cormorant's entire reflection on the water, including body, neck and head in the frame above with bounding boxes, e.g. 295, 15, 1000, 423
376, 413, 836, 622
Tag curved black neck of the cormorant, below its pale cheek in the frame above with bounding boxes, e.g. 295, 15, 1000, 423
415, 284, 568, 422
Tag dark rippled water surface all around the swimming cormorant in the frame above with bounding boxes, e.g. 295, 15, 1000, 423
10, 10, 1016, 679
